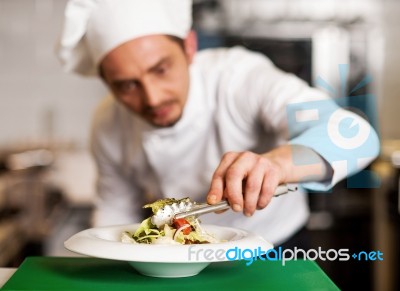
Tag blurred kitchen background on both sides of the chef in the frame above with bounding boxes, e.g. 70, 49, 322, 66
0, 0, 400, 290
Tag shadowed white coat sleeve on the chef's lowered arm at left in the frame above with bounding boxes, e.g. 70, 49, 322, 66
90, 97, 143, 226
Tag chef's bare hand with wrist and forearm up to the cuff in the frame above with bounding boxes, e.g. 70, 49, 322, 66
207, 145, 333, 216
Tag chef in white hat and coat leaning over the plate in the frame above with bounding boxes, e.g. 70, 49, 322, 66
57, 0, 379, 244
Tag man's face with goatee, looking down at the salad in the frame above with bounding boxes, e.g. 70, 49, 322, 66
100, 35, 194, 127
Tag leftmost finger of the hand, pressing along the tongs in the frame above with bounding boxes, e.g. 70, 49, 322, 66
207, 152, 238, 204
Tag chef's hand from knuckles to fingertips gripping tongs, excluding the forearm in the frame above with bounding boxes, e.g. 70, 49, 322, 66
207, 152, 285, 216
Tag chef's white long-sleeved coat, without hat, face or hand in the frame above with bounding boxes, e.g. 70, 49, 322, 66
91, 47, 379, 244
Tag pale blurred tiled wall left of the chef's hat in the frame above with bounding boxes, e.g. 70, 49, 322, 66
0, 0, 105, 147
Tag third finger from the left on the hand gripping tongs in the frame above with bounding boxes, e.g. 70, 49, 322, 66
243, 166, 265, 216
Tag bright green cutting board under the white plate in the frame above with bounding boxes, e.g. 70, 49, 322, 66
1, 257, 339, 291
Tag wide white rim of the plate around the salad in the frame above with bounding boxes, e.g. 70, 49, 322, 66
64, 223, 273, 263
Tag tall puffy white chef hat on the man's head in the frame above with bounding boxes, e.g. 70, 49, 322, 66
56, 0, 192, 75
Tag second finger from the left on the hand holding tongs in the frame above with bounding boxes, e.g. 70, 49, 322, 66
225, 153, 254, 211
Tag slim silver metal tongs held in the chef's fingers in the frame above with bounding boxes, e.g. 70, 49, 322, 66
174, 184, 297, 219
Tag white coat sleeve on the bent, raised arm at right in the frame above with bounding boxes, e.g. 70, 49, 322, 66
223, 48, 379, 191
